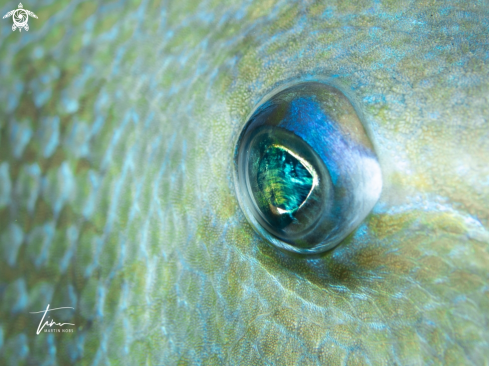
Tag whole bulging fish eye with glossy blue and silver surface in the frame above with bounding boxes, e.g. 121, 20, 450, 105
234, 82, 382, 254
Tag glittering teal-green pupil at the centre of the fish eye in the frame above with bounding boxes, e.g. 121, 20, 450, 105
257, 145, 316, 214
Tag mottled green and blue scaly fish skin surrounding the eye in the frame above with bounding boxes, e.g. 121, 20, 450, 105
0, 0, 489, 365
